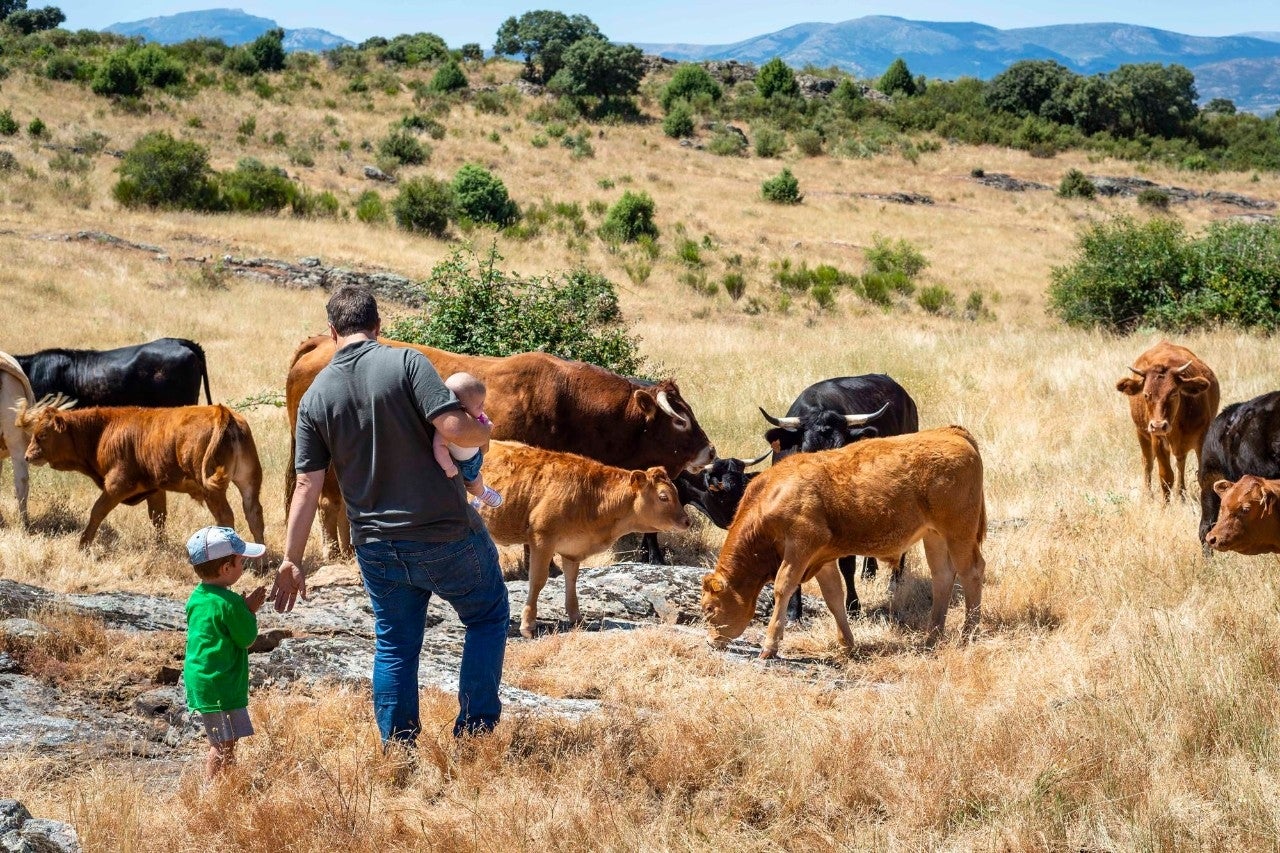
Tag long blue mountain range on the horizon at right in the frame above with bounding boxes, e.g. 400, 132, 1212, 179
637, 15, 1280, 113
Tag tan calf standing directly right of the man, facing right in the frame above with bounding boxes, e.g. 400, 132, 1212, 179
480, 442, 690, 637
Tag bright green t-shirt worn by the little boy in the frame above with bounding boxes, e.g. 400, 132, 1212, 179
182, 584, 257, 713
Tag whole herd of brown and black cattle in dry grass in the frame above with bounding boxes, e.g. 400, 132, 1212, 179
0, 336, 1280, 657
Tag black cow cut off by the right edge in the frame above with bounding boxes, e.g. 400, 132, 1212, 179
1197, 391, 1280, 540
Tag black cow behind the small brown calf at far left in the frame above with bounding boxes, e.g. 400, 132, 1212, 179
14, 338, 212, 407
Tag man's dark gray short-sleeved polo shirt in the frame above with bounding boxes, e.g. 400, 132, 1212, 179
293, 341, 483, 544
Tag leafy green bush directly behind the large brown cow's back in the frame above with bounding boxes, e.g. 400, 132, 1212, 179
385, 242, 645, 375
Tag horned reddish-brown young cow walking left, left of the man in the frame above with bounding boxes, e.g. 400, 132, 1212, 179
17, 401, 264, 548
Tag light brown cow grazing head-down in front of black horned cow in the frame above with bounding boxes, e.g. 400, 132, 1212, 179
703, 427, 987, 658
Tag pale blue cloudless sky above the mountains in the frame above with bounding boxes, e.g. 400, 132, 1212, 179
55, 0, 1280, 49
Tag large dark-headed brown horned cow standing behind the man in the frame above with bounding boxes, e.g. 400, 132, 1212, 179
284, 334, 716, 552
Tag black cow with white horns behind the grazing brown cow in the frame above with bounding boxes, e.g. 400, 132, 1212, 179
760, 373, 920, 619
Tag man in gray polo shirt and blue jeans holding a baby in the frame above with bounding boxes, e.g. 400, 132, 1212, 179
271, 287, 509, 743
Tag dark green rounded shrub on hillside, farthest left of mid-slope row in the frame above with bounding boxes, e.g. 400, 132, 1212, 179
111, 131, 218, 210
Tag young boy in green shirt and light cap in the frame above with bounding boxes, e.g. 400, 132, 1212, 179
182, 528, 266, 780
